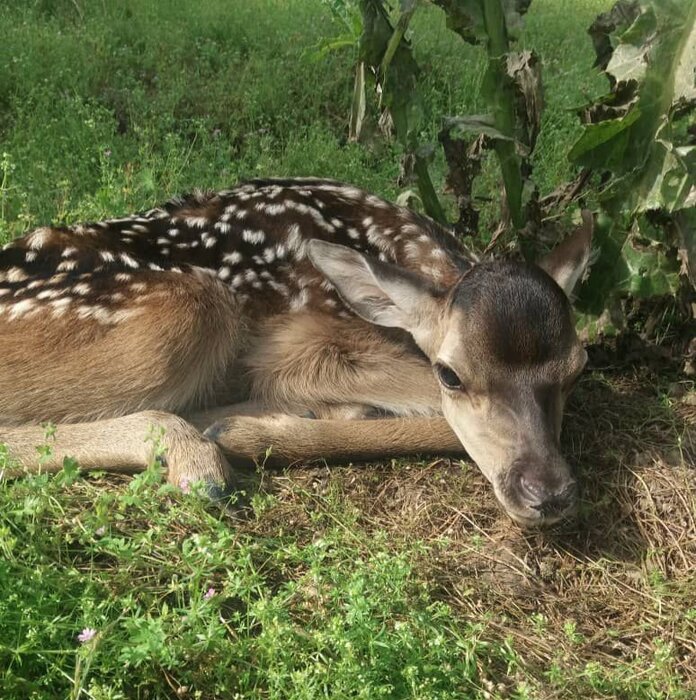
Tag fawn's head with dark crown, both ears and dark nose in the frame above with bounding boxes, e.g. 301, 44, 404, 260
310, 212, 592, 526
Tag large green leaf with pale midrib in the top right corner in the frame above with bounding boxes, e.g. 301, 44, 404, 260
569, 0, 696, 211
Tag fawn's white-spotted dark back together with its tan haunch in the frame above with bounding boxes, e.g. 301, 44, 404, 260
0, 179, 470, 424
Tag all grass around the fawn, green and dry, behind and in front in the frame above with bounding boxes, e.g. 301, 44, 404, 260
0, 0, 696, 700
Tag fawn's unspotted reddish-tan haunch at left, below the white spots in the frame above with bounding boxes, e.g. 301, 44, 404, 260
0, 272, 241, 425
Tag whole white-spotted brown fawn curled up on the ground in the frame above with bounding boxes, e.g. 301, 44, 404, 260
0, 179, 592, 525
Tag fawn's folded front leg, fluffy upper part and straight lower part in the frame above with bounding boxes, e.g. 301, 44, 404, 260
190, 312, 464, 465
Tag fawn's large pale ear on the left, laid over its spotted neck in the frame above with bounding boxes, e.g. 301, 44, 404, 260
308, 238, 439, 335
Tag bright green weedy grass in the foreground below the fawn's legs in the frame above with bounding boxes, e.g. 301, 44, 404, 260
0, 462, 494, 698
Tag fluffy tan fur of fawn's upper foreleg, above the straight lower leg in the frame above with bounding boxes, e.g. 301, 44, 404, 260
244, 312, 440, 415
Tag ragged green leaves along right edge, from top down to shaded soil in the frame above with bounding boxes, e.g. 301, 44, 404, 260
569, 0, 696, 325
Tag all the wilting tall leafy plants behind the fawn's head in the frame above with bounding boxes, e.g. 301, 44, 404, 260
348, 0, 696, 338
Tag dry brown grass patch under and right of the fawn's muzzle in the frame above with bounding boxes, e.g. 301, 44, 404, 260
244, 370, 696, 698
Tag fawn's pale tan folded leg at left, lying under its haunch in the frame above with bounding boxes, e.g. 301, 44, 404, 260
0, 411, 233, 497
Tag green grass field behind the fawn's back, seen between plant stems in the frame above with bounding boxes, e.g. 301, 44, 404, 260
0, 0, 608, 239
